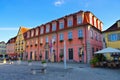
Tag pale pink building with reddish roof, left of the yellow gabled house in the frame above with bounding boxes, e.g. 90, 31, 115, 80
6, 37, 17, 59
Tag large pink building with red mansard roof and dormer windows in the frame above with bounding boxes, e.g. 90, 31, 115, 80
24, 11, 102, 63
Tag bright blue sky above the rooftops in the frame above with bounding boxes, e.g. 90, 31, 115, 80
0, 0, 120, 42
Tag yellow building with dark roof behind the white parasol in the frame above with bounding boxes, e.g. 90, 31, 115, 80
103, 20, 120, 60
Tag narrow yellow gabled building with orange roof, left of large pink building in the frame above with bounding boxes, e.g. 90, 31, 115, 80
15, 27, 29, 58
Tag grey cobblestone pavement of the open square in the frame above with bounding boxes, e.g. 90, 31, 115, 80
0, 62, 120, 80
